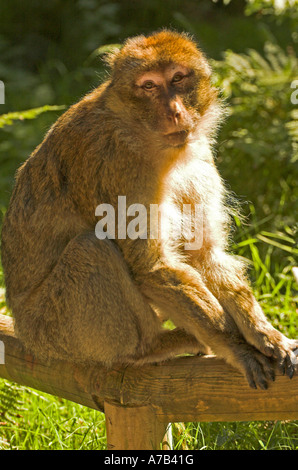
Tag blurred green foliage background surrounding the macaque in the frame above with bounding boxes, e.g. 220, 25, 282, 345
0, 0, 298, 448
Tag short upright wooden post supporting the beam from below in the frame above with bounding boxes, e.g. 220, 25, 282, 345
104, 401, 170, 450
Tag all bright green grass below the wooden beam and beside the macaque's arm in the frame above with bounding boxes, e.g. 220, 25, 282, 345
0, 226, 298, 450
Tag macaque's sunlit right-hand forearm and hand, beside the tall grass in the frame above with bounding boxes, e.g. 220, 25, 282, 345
194, 253, 298, 378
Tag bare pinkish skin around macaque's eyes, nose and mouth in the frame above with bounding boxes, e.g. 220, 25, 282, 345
136, 64, 190, 146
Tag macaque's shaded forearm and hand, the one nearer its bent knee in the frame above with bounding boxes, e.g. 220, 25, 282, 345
139, 266, 274, 388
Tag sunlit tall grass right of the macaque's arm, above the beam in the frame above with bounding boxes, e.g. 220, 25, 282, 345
232, 221, 298, 338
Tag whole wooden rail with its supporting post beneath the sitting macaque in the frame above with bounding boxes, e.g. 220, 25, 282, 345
0, 315, 298, 450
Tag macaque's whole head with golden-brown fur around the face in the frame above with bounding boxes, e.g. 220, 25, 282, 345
108, 31, 217, 147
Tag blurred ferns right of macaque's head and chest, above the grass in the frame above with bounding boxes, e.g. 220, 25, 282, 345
214, 43, 298, 230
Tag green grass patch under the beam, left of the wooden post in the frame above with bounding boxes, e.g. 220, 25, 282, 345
0, 380, 106, 450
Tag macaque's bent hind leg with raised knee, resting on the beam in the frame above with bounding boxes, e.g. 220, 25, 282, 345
16, 233, 198, 366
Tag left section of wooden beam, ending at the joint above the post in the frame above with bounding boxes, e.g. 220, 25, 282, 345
0, 315, 112, 411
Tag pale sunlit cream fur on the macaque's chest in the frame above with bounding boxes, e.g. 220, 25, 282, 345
162, 139, 229, 264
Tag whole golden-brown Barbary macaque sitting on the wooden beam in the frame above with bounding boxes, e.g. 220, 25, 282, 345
2, 30, 298, 389
